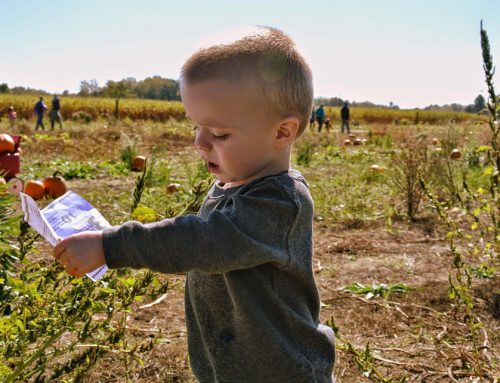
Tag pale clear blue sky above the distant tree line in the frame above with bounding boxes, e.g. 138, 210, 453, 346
0, 0, 500, 108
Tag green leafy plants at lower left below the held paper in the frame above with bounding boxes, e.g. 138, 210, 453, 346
0, 166, 169, 383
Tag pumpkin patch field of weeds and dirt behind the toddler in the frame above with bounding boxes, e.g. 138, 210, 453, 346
0, 109, 500, 383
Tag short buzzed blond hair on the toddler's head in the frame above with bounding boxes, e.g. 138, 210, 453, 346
181, 27, 313, 137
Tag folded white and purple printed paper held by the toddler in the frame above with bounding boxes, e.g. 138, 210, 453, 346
19, 191, 111, 282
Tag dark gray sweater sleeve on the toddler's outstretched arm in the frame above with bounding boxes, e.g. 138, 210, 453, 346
103, 181, 298, 273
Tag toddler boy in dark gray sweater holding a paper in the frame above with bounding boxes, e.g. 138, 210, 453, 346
54, 28, 335, 383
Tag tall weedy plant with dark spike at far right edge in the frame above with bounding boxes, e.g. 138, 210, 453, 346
421, 22, 500, 381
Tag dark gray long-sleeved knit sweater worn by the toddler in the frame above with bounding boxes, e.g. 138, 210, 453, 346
103, 170, 335, 383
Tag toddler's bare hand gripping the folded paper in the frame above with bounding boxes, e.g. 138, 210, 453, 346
53, 231, 106, 278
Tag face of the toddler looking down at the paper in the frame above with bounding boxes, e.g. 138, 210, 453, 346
181, 80, 283, 187
